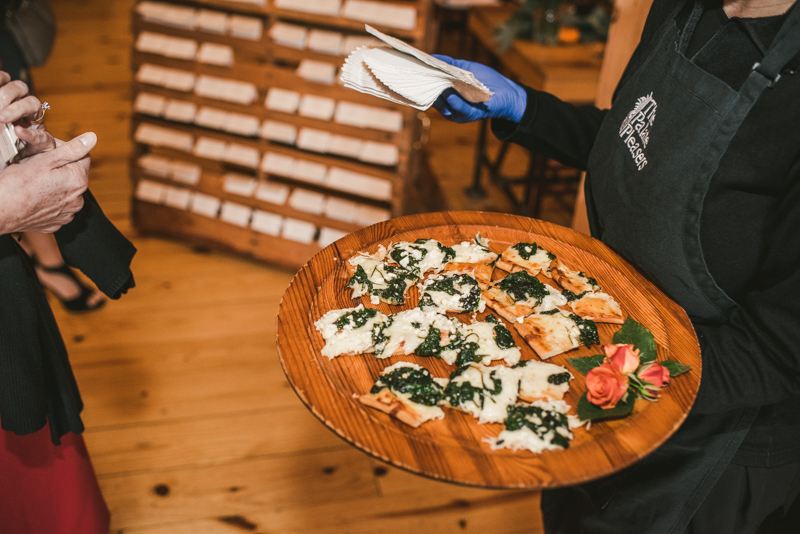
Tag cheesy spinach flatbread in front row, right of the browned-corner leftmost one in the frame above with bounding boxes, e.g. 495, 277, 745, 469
443, 363, 519, 424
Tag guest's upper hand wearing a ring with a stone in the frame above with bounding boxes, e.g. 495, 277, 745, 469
0, 72, 56, 161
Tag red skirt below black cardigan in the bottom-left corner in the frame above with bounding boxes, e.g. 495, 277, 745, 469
0, 425, 110, 534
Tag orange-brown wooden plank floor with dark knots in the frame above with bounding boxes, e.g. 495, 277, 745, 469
34, 0, 552, 534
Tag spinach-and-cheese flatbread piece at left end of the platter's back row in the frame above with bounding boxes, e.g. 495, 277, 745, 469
347, 246, 419, 305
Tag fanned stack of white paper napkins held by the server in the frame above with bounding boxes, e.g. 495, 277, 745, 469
341, 26, 494, 111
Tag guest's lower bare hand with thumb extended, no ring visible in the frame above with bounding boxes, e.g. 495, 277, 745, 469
0, 132, 97, 235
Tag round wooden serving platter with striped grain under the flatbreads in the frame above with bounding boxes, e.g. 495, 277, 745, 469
278, 212, 701, 489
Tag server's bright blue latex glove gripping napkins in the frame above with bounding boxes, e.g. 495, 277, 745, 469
433, 54, 528, 123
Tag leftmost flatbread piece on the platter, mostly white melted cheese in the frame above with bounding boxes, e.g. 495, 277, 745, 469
314, 304, 388, 360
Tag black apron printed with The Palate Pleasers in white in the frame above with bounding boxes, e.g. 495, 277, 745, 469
560, 2, 800, 534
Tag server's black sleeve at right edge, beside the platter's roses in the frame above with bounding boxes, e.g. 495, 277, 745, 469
694, 162, 800, 413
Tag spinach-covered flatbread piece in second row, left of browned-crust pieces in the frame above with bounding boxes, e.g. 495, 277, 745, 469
419, 273, 486, 313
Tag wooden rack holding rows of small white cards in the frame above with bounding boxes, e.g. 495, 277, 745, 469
131, 0, 434, 269
